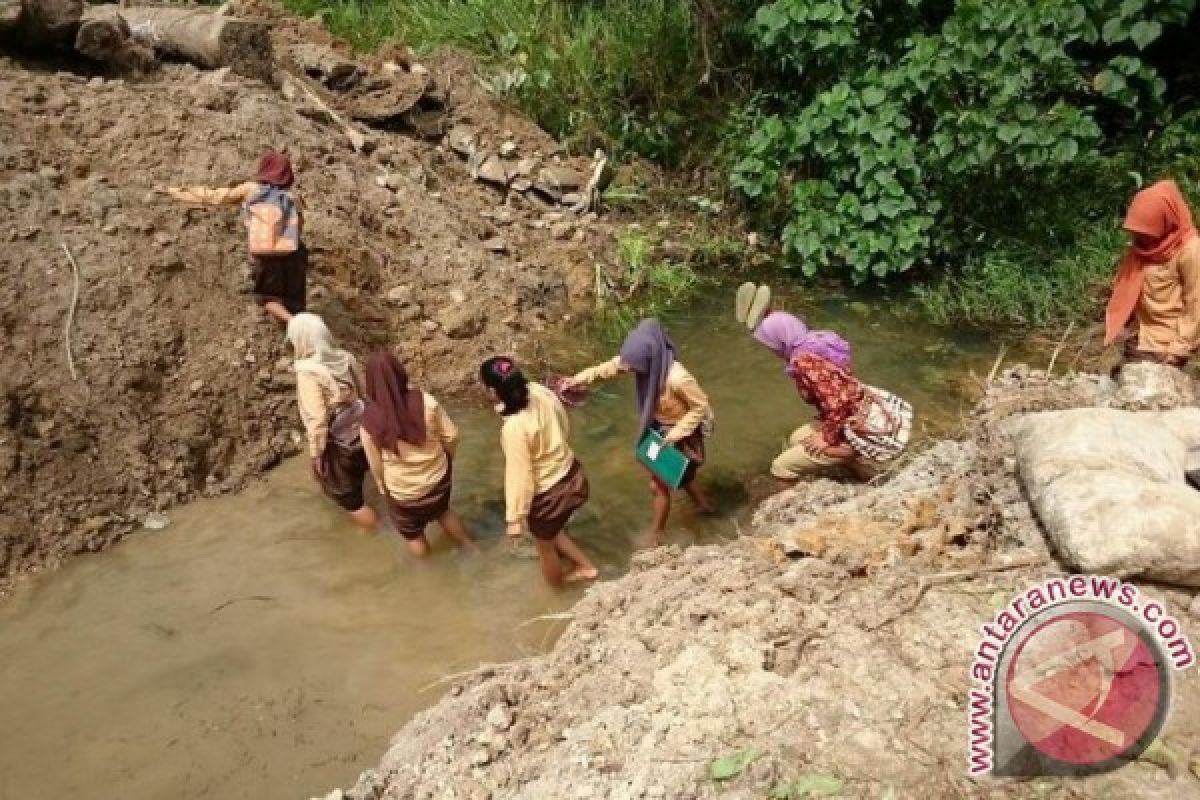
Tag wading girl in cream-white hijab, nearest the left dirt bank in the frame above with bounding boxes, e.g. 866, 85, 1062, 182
288, 313, 377, 528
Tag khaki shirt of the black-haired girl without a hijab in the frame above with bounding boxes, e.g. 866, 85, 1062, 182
500, 383, 575, 524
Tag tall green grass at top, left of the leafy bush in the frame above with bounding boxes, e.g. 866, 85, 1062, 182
284, 0, 721, 164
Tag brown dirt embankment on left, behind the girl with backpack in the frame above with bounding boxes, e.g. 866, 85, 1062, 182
0, 4, 611, 583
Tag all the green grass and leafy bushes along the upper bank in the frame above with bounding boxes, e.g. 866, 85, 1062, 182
286, 0, 1200, 325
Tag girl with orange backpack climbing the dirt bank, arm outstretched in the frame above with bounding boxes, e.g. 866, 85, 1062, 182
163, 150, 308, 323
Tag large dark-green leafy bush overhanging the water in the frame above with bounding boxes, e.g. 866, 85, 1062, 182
730, 0, 1195, 282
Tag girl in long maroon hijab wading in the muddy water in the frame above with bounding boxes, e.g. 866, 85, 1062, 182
362, 351, 475, 557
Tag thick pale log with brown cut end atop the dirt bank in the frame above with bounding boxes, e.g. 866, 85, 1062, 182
89, 0, 275, 85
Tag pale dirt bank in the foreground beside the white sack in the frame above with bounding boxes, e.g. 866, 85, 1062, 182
326, 371, 1200, 800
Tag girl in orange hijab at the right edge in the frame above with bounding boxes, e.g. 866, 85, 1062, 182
1104, 181, 1200, 367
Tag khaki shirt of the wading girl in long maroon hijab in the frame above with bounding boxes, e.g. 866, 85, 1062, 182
360, 392, 458, 503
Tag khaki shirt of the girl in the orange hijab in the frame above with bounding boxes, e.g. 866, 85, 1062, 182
1135, 236, 1200, 356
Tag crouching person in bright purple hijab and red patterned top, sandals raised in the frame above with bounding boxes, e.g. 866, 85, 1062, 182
734, 284, 912, 487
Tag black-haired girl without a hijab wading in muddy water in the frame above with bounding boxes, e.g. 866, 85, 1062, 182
479, 356, 599, 588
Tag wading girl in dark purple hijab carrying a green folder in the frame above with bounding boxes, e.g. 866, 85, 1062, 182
564, 319, 713, 547
